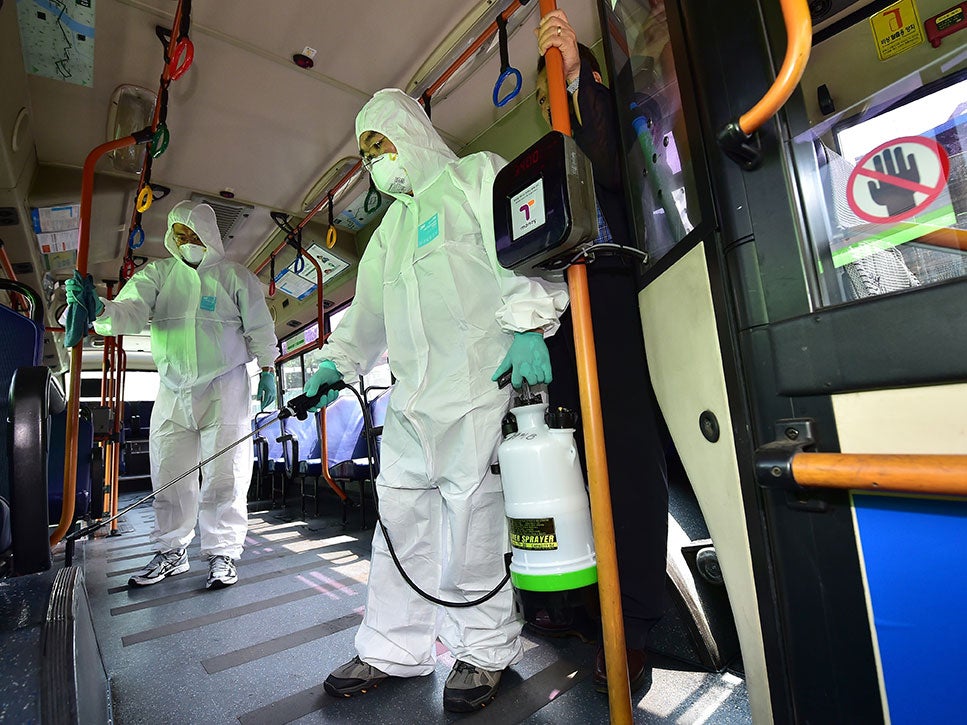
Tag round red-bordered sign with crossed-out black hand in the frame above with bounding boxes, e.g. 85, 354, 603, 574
846, 136, 950, 224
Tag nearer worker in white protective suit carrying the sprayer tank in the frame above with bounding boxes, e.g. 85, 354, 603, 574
305, 89, 567, 711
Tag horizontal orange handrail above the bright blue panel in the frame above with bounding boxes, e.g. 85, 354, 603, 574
792, 453, 967, 496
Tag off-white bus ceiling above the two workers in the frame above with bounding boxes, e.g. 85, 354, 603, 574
28, 0, 600, 268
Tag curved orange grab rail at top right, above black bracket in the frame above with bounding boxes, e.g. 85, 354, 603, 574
717, 0, 813, 171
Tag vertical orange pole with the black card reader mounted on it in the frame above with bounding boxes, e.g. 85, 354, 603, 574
540, 0, 633, 725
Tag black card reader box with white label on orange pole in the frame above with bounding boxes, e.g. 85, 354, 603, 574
494, 131, 598, 273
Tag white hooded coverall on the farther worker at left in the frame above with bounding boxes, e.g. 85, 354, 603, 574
94, 202, 277, 559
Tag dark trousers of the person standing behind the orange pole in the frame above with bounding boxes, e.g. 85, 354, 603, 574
547, 257, 668, 649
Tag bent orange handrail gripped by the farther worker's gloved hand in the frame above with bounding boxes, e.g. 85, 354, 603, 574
50, 133, 150, 546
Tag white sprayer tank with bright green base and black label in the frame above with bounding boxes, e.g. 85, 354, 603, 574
497, 403, 598, 592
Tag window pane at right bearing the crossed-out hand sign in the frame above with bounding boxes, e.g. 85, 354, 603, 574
796, 53, 967, 305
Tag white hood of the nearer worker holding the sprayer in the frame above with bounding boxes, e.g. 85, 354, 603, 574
356, 88, 457, 199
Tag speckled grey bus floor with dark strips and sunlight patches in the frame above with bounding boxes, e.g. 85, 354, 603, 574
84, 494, 751, 725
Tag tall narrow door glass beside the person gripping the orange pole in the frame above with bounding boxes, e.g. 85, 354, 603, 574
603, 0, 699, 262
